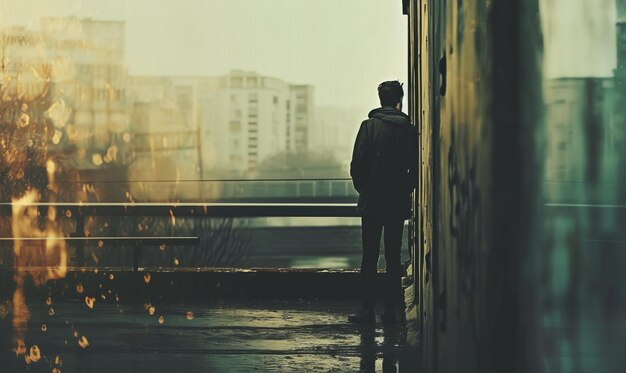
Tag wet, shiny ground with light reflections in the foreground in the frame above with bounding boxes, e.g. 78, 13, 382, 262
0, 300, 417, 373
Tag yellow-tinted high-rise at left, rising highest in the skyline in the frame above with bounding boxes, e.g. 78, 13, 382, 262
41, 17, 129, 168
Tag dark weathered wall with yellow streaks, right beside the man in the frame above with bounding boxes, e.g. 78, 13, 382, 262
409, 0, 541, 372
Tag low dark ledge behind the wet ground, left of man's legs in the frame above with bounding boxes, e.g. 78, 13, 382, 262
0, 267, 390, 303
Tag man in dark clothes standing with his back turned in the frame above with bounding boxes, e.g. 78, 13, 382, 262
348, 81, 417, 323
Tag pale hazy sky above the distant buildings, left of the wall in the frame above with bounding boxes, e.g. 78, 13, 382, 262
0, 0, 407, 109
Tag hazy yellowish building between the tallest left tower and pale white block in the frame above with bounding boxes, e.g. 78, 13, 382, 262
128, 76, 201, 200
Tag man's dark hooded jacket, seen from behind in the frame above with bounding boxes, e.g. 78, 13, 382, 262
350, 106, 417, 219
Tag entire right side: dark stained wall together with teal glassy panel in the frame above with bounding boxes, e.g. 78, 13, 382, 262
408, 0, 626, 372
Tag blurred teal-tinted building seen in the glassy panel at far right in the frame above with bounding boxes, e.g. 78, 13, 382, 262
544, 78, 620, 183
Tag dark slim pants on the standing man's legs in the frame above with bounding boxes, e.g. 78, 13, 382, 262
361, 216, 404, 311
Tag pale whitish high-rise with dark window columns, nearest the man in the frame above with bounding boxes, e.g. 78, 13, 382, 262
198, 71, 314, 178
